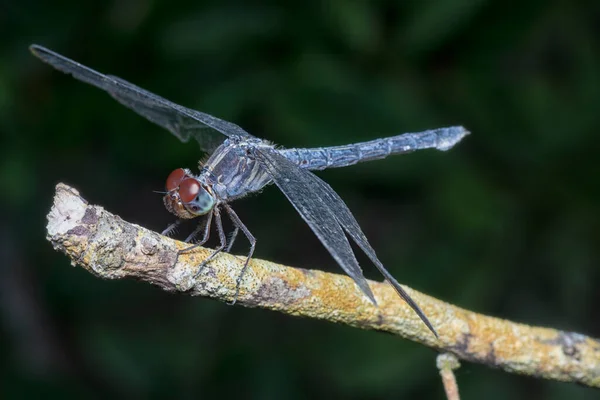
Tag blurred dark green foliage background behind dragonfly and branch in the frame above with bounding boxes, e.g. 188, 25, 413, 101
0, 0, 600, 400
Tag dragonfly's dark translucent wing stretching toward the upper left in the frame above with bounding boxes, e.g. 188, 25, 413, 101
30, 45, 252, 152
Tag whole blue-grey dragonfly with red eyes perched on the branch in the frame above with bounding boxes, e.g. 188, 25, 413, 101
30, 45, 469, 337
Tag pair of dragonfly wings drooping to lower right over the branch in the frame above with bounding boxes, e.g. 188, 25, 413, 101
254, 145, 437, 337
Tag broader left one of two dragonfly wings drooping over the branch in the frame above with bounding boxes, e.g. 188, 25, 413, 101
253, 149, 377, 304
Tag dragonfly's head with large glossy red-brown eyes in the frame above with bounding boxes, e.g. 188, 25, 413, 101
163, 168, 215, 219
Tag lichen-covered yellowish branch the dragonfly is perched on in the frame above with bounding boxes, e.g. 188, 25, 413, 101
47, 184, 600, 388
